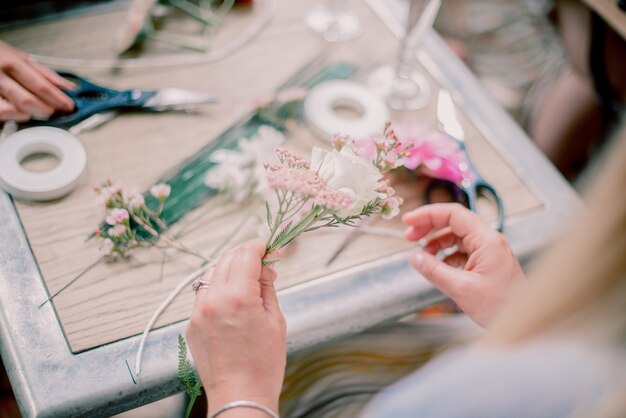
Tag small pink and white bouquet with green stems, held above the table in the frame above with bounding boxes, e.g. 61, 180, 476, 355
265, 124, 407, 262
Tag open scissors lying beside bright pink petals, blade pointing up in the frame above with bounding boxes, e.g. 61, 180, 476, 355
426, 89, 504, 232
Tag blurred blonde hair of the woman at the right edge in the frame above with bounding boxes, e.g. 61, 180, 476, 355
482, 124, 626, 344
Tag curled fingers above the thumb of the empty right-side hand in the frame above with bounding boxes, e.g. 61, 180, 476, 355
402, 203, 494, 253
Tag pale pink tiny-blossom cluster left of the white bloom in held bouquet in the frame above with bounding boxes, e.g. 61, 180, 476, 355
265, 148, 352, 211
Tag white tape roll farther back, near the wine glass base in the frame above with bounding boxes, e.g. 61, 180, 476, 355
304, 80, 389, 141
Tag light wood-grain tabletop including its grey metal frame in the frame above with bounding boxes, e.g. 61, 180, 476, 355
0, 1, 579, 416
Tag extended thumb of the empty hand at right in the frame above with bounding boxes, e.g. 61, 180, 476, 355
409, 250, 466, 299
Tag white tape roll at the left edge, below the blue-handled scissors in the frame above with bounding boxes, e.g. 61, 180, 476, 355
0, 127, 87, 201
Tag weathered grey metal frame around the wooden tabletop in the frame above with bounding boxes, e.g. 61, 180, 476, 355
0, 25, 581, 417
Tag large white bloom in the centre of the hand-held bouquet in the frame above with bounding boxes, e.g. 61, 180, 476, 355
311, 147, 382, 218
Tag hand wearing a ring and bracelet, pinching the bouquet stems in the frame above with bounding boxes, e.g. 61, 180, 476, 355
186, 241, 286, 418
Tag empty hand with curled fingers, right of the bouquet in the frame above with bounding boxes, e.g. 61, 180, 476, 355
402, 203, 525, 326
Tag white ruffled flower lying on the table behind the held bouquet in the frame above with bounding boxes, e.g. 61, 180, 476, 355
204, 126, 285, 202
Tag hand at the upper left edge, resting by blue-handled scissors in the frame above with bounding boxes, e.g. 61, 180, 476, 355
0, 41, 75, 122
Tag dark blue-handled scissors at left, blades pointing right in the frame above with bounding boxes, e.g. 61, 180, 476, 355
27, 72, 217, 134
